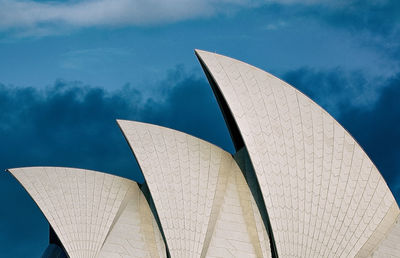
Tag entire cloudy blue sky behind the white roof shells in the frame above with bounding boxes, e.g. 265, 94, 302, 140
0, 0, 400, 257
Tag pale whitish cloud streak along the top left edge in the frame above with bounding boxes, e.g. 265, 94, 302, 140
0, 0, 255, 32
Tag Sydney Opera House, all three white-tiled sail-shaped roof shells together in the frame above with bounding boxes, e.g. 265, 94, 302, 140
8, 50, 400, 257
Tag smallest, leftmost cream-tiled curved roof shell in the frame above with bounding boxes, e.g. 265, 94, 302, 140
9, 167, 166, 257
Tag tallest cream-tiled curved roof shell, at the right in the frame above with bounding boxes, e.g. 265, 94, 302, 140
196, 50, 399, 257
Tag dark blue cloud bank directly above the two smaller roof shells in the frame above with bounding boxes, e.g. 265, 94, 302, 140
0, 67, 229, 180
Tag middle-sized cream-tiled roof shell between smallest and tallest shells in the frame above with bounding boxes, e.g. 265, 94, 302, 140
118, 120, 270, 257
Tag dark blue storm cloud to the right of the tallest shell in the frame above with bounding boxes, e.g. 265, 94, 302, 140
284, 68, 400, 202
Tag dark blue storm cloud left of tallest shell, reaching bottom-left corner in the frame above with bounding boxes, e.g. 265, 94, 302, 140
0, 68, 232, 257
